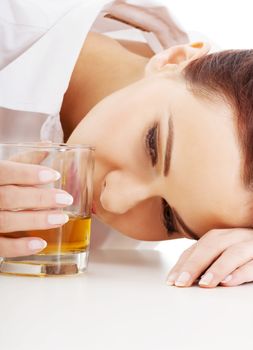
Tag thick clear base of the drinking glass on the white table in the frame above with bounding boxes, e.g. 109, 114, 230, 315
0, 251, 89, 277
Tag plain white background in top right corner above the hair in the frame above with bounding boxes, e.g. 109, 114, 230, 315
167, 0, 253, 49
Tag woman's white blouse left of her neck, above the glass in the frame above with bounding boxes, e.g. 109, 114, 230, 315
0, 0, 108, 142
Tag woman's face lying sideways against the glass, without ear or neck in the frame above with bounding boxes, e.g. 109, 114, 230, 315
69, 56, 250, 240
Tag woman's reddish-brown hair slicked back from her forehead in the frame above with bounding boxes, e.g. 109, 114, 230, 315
183, 50, 253, 189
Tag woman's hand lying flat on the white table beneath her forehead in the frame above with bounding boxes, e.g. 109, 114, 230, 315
167, 229, 253, 288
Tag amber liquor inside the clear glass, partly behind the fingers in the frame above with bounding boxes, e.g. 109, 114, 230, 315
0, 216, 91, 255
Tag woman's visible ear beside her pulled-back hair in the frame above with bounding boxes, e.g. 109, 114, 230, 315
145, 42, 210, 76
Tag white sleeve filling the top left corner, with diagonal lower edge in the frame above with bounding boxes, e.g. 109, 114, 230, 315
0, 0, 82, 69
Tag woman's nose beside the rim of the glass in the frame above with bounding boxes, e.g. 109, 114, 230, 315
100, 171, 151, 214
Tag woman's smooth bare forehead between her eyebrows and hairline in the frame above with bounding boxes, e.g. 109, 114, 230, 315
162, 79, 250, 229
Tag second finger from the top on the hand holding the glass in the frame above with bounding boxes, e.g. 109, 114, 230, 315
0, 185, 73, 211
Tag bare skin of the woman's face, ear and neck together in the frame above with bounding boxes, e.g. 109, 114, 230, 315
61, 32, 253, 240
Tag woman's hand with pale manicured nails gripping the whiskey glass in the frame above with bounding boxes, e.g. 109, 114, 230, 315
0, 160, 72, 257
